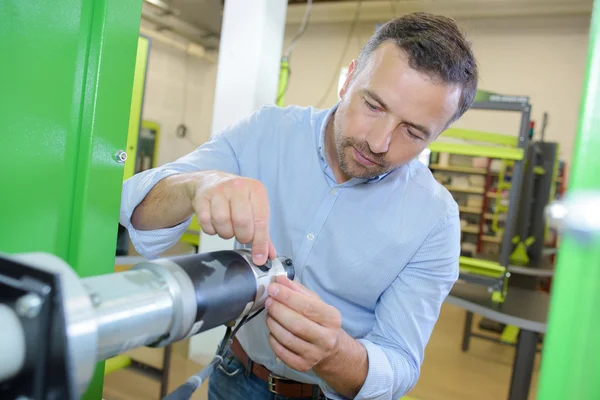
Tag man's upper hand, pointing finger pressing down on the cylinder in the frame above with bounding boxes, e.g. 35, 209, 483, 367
188, 171, 277, 265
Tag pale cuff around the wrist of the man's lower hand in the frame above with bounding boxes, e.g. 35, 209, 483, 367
320, 339, 397, 400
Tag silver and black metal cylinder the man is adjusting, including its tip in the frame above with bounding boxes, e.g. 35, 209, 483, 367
82, 250, 294, 361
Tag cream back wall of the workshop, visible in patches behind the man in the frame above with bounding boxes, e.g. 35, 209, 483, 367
144, 16, 589, 169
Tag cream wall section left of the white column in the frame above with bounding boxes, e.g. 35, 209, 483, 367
143, 28, 217, 165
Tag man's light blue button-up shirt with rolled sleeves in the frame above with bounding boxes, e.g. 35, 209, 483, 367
121, 106, 460, 400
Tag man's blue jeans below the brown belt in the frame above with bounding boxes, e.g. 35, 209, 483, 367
208, 350, 328, 400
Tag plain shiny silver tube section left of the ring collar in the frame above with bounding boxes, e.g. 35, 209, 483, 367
83, 269, 176, 361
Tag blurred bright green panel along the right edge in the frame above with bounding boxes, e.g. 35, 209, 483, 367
538, 0, 600, 400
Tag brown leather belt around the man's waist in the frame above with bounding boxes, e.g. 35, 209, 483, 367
231, 338, 323, 398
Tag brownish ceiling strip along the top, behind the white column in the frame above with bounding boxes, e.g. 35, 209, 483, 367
143, 0, 593, 50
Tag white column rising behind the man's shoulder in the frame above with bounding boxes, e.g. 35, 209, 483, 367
190, 0, 287, 365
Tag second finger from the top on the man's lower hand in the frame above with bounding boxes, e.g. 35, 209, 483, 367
265, 295, 327, 344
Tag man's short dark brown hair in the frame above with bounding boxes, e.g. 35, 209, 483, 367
355, 12, 478, 122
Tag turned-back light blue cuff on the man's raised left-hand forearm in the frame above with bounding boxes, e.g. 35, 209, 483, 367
119, 169, 192, 260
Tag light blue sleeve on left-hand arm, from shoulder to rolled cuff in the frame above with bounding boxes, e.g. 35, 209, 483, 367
119, 110, 262, 259
